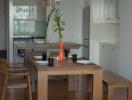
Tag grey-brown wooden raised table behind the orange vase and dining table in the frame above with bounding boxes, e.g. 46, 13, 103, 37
14, 41, 81, 65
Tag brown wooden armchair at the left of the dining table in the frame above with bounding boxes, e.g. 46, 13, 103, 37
0, 59, 32, 100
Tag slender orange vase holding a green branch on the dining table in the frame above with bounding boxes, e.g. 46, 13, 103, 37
58, 41, 64, 64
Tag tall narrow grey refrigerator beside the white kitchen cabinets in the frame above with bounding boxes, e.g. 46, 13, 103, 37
82, 6, 90, 59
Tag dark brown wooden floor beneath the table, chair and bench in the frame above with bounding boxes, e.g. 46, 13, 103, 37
6, 80, 126, 100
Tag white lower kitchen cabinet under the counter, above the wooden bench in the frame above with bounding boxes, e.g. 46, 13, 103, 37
99, 43, 118, 72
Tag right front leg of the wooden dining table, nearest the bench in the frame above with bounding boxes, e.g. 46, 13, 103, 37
93, 71, 103, 100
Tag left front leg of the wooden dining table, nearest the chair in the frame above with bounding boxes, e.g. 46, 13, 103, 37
37, 72, 48, 100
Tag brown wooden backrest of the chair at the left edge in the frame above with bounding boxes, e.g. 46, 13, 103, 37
0, 58, 8, 100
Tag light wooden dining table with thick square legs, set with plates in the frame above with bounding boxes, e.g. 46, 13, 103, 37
31, 57, 102, 100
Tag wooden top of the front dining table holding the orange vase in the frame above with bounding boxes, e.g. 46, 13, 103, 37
30, 57, 102, 75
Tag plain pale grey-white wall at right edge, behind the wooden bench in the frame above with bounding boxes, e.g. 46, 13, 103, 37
119, 0, 132, 80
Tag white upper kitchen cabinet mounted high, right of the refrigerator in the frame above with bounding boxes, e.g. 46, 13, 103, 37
92, 0, 119, 23
